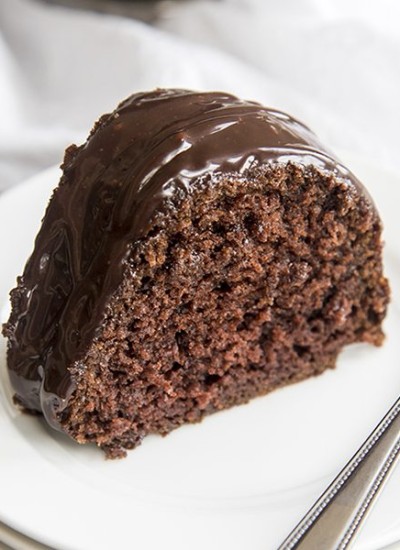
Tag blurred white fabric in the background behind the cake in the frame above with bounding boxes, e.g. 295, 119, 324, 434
0, 0, 400, 194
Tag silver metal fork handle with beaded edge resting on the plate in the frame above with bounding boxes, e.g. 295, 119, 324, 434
278, 398, 400, 550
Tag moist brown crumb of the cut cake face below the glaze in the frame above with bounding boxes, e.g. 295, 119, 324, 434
58, 163, 387, 458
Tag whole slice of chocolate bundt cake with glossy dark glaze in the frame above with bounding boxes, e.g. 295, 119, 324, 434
3, 90, 389, 457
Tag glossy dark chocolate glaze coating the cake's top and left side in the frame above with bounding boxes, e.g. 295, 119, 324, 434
5, 90, 364, 427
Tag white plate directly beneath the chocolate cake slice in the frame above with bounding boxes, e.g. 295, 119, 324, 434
0, 155, 400, 550
